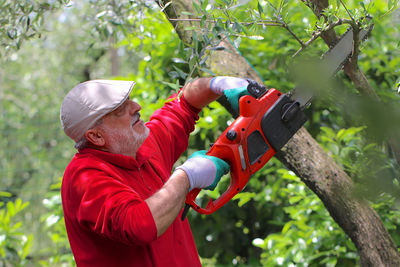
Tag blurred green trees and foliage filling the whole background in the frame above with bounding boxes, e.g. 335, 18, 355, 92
0, 0, 400, 266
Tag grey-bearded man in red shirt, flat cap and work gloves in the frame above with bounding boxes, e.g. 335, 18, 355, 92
60, 76, 248, 267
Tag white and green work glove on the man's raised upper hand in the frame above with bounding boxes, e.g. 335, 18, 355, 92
210, 76, 249, 113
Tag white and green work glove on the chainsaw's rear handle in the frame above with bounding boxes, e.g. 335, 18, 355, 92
176, 150, 229, 191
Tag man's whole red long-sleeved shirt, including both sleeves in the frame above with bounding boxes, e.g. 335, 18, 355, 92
61, 93, 201, 267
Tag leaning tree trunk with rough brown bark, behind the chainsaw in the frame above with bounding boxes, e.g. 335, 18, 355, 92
159, 0, 400, 266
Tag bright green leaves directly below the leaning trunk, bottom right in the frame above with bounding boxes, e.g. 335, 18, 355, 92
253, 169, 358, 266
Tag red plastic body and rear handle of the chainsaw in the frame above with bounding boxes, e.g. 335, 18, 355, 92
186, 88, 282, 214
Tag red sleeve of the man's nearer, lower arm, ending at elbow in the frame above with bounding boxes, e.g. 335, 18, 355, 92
69, 168, 157, 244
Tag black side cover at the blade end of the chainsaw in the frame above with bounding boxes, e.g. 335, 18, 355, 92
261, 95, 307, 151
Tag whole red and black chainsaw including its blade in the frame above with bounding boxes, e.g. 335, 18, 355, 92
182, 19, 373, 220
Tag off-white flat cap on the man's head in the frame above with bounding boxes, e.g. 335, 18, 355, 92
60, 80, 135, 142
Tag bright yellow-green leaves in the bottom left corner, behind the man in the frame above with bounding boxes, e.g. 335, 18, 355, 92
0, 192, 33, 266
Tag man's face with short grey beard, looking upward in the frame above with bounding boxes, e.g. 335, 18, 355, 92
99, 99, 149, 157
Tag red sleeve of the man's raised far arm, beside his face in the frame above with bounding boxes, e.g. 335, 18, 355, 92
146, 94, 200, 169
